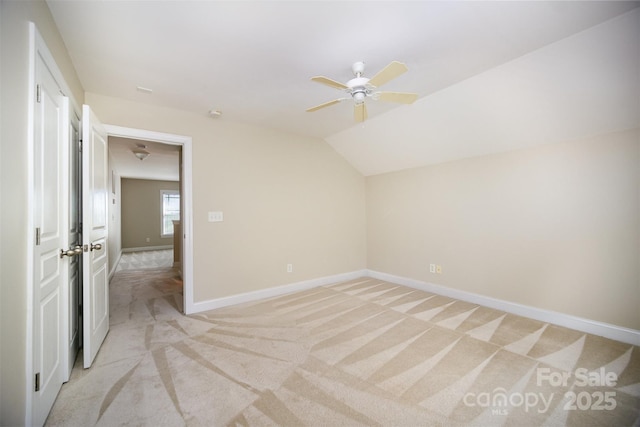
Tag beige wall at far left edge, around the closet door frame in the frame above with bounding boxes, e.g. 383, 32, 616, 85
0, 0, 84, 426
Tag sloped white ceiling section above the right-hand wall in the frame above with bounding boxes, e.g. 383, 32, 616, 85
327, 10, 640, 175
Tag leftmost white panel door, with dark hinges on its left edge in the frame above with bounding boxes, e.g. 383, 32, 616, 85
29, 49, 68, 425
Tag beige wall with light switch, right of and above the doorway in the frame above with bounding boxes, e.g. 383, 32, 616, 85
86, 93, 366, 302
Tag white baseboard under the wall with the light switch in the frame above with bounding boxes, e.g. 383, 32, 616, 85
189, 270, 367, 314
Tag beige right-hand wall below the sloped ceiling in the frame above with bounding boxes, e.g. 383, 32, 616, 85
366, 130, 640, 329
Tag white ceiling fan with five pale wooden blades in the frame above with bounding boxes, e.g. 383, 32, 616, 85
307, 61, 418, 122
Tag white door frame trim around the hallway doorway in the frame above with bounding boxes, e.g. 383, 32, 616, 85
104, 124, 195, 314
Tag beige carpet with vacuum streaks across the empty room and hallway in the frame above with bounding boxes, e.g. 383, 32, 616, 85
47, 269, 640, 426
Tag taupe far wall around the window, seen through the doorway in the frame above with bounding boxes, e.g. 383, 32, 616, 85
121, 178, 180, 249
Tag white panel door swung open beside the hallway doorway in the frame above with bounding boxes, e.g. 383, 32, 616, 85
82, 105, 109, 368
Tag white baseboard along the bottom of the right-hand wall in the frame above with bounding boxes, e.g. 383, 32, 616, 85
366, 270, 640, 346
